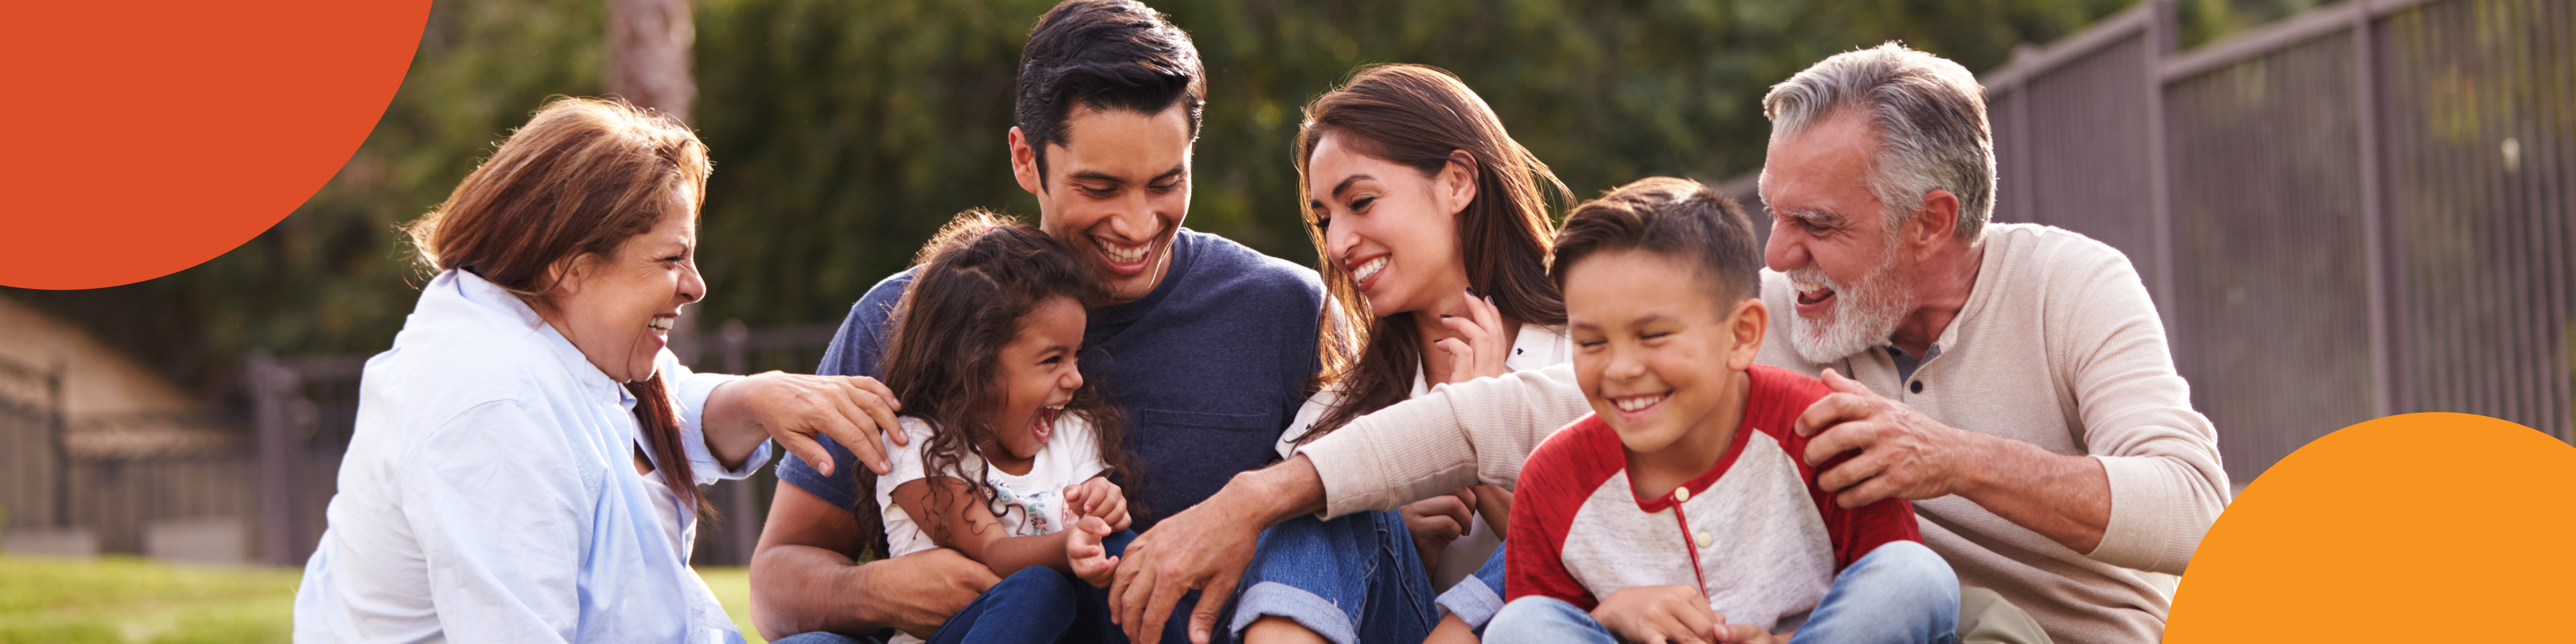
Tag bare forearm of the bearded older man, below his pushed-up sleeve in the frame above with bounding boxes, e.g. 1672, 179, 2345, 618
1958, 435, 2110, 551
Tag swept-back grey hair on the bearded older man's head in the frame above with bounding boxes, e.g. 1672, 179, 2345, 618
1762, 41, 1994, 245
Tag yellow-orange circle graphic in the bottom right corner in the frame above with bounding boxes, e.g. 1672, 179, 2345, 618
2164, 412, 2576, 644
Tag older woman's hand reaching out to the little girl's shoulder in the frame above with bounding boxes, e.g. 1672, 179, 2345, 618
703, 371, 912, 477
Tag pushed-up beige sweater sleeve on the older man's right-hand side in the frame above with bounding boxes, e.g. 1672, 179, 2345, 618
2056, 253, 2228, 574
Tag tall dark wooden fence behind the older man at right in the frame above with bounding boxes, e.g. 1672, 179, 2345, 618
1984, 0, 2576, 482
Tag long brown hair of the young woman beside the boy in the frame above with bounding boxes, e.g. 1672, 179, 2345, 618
1296, 64, 1571, 440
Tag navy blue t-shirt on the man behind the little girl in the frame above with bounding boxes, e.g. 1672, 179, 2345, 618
778, 229, 1324, 531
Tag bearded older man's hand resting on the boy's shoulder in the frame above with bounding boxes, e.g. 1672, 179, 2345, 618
1793, 368, 1994, 507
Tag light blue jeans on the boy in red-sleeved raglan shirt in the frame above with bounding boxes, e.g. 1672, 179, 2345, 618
1484, 541, 1958, 644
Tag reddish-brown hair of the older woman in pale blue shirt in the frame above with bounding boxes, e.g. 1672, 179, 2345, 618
404, 98, 714, 515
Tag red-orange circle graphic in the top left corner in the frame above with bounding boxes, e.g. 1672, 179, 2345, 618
0, 0, 430, 289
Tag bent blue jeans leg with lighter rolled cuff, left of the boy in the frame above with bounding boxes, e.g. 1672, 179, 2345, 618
1226, 510, 1440, 644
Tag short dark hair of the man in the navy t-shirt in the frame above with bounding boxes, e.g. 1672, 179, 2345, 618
1015, 0, 1208, 178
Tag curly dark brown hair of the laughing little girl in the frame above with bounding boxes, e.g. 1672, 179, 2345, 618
850, 211, 1139, 554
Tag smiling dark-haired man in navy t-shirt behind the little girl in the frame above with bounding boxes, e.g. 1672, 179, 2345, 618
750, 0, 1324, 641
